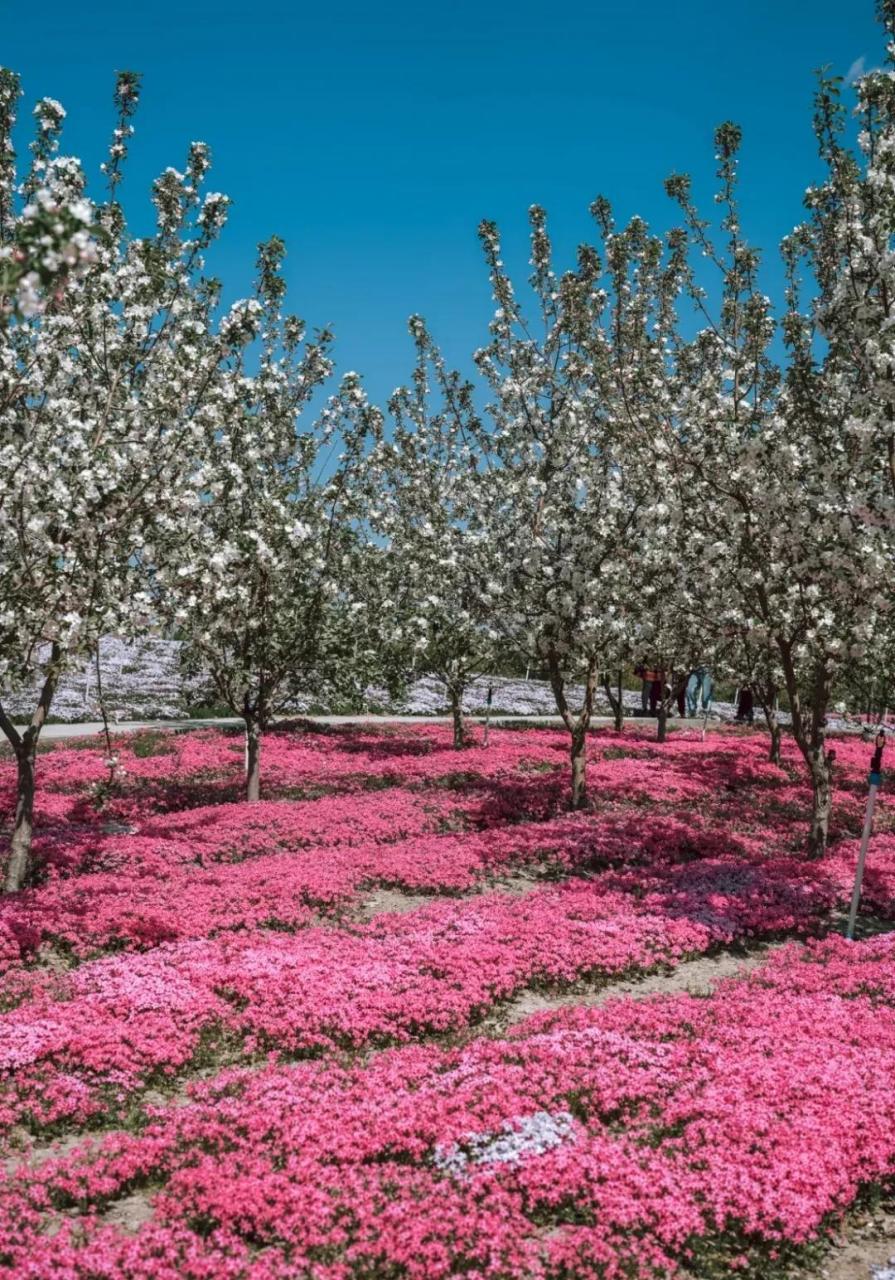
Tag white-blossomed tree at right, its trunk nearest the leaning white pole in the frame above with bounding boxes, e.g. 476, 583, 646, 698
668, 107, 891, 855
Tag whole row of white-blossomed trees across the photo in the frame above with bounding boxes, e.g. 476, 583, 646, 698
0, 0, 895, 891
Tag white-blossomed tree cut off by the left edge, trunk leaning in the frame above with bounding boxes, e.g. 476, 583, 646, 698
0, 73, 263, 891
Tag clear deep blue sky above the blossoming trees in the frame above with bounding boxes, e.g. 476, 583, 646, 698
0, 0, 882, 397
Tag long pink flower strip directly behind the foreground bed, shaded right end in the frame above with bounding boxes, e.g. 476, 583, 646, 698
0, 860, 831, 1128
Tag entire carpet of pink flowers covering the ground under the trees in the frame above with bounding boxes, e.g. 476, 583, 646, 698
0, 724, 895, 1280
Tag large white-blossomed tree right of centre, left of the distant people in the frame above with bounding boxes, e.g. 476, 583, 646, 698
476, 200, 676, 808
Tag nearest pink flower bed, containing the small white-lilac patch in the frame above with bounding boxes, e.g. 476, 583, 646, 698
0, 940, 895, 1280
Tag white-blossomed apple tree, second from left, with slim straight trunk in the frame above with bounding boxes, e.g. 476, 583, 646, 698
170, 239, 379, 800
